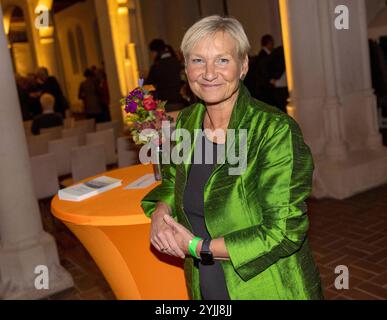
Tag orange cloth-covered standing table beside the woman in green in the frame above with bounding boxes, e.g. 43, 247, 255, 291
51, 165, 188, 300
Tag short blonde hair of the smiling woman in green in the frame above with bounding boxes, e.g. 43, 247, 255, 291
180, 15, 250, 63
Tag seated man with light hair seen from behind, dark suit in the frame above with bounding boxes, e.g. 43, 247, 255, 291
31, 93, 63, 135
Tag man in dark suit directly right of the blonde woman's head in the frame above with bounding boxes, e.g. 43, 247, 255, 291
244, 34, 274, 104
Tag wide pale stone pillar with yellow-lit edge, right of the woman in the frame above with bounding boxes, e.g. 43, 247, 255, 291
279, 0, 387, 199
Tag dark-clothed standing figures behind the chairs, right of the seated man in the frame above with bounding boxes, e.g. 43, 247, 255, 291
78, 66, 111, 122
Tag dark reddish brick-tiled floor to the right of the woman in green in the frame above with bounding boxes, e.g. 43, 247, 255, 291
308, 185, 387, 299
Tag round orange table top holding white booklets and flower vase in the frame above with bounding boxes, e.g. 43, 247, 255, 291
51, 164, 160, 226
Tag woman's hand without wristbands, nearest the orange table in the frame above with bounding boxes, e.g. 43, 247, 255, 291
150, 203, 185, 259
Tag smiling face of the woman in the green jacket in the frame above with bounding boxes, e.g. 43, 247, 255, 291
186, 32, 248, 104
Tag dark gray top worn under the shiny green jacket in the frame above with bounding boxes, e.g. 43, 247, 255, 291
183, 130, 230, 300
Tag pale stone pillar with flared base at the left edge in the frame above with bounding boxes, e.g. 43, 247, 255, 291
0, 8, 73, 299
